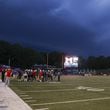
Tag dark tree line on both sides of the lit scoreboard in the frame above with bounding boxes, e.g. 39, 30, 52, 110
0, 41, 110, 69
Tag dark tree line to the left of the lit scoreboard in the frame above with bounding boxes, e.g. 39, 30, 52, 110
0, 41, 63, 68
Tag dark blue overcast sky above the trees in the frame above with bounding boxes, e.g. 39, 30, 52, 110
0, 0, 110, 56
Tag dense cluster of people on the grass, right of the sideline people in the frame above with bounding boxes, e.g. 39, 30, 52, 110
17, 69, 61, 82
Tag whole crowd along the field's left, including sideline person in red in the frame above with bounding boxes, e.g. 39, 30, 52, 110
1, 68, 61, 86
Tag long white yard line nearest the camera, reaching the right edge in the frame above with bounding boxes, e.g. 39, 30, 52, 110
31, 97, 110, 106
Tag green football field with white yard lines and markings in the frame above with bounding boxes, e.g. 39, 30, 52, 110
10, 76, 110, 110
